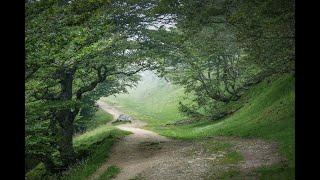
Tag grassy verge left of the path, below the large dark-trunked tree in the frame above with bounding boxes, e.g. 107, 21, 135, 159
26, 111, 130, 180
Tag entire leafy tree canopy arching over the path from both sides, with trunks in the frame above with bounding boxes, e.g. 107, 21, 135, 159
25, 0, 295, 172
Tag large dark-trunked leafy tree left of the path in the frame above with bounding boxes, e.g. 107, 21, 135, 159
25, 0, 159, 170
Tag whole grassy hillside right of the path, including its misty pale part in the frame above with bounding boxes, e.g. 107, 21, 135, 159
107, 71, 295, 179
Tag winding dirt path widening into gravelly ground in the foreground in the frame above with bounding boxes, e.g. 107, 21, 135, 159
89, 101, 280, 180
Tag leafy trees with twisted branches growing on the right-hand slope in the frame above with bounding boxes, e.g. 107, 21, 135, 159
150, 0, 295, 119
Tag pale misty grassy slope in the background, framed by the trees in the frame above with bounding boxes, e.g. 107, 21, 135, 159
107, 71, 184, 126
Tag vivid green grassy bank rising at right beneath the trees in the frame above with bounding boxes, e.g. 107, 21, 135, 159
156, 75, 295, 173
